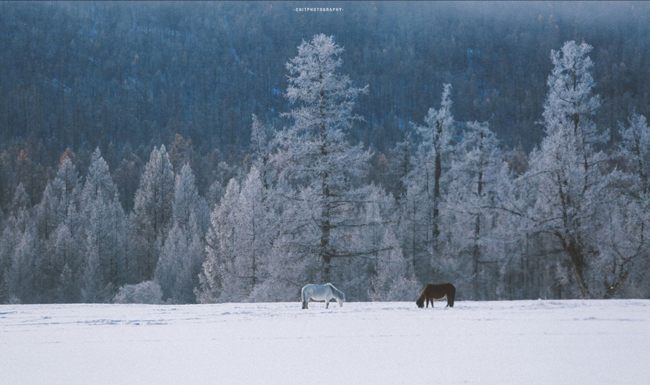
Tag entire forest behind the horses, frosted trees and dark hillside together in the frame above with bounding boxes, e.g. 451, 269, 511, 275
0, 2, 650, 303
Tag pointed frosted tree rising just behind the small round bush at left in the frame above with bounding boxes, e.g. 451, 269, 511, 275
131, 145, 175, 281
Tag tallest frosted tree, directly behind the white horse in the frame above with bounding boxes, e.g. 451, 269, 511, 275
273, 34, 371, 281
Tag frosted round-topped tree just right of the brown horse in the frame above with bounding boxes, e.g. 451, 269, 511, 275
444, 122, 509, 299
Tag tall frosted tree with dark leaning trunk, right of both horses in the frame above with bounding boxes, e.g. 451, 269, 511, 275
520, 41, 607, 297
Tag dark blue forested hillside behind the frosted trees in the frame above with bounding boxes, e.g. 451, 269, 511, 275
0, 2, 650, 209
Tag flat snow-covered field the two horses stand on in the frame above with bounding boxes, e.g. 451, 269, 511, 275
0, 300, 650, 385
